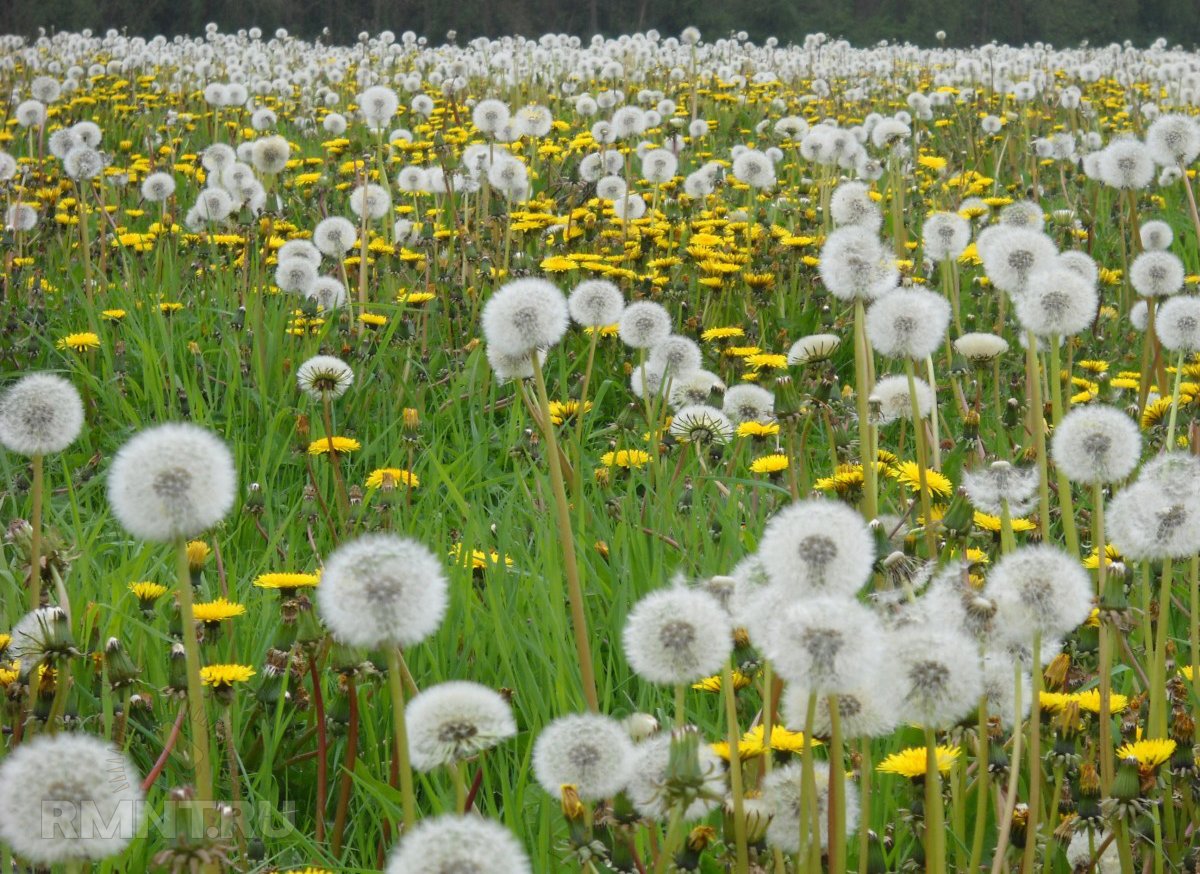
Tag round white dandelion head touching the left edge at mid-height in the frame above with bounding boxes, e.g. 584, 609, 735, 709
0, 373, 84, 456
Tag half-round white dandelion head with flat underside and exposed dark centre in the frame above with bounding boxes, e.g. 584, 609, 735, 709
404, 681, 517, 771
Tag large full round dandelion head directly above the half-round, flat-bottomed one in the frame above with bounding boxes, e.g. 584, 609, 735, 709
317, 534, 449, 647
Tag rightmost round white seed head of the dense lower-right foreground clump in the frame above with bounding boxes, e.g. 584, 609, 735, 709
984, 544, 1093, 637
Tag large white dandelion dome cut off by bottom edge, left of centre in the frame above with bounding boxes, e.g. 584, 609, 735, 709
385, 813, 533, 874
